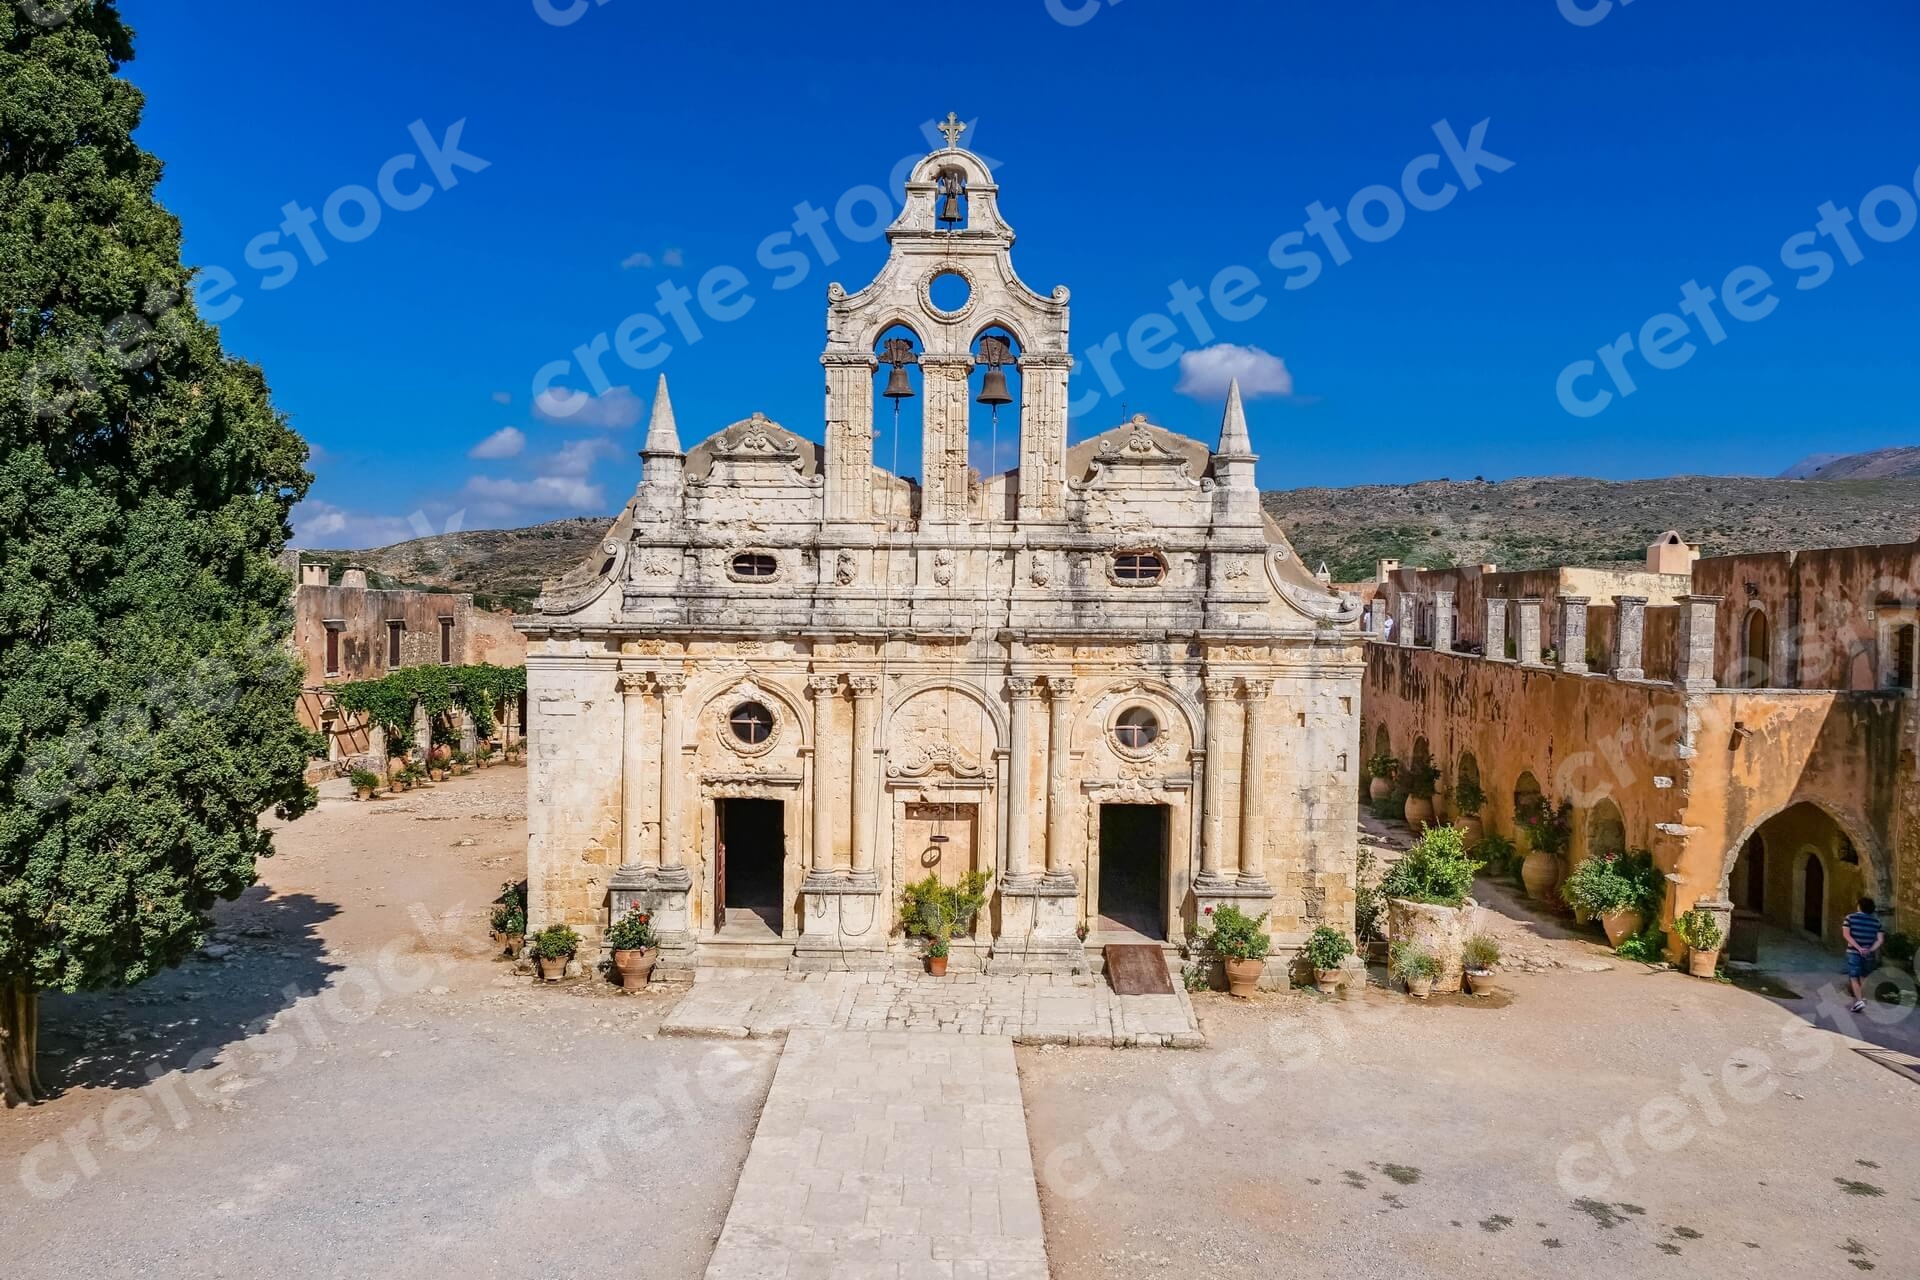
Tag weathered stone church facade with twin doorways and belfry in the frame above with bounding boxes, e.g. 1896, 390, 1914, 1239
520, 127, 1363, 977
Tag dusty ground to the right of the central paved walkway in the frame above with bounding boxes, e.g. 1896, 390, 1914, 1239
1020, 883, 1920, 1280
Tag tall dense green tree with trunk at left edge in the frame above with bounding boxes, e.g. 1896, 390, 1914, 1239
0, 0, 321, 1105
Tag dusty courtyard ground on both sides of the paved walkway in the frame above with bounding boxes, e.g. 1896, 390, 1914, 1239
0, 768, 1920, 1280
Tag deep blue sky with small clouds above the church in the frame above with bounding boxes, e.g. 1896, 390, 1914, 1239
125, 0, 1920, 547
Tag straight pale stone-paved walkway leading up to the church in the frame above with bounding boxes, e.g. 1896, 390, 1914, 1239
707, 1029, 1048, 1280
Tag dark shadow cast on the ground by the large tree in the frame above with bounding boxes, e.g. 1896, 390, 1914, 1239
40, 885, 344, 1098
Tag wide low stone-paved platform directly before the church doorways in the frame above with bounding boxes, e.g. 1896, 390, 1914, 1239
660, 969, 1206, 1048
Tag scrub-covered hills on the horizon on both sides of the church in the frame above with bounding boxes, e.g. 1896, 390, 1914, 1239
301, 475, 1920, 612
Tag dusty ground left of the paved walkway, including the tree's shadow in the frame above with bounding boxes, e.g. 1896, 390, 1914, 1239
0, 768, 778, 1280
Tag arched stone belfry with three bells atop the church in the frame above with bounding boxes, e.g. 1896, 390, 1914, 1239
820, 113, 1073, 526
